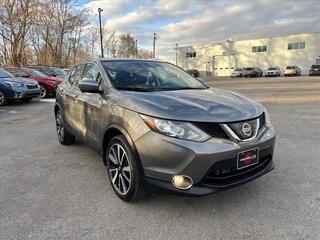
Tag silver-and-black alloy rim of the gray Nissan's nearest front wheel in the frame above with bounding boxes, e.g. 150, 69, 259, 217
108, 143, 132, 195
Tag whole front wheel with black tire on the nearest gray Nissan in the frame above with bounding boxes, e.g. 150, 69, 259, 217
105, 135, 148, 202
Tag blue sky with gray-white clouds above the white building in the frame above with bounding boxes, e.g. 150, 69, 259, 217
81, 0, 320, 62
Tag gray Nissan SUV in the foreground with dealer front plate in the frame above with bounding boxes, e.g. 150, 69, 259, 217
54, 59, 275, 201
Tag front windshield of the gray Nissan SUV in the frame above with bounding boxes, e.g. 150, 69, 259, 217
102, 60, 207, 91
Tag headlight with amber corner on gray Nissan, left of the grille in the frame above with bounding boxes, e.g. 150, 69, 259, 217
140, 115, 210, 142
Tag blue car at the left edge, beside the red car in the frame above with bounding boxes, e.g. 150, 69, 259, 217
0, 69, 40, 106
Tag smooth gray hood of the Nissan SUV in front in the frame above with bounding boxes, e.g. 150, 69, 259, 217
117, 88, 263, 122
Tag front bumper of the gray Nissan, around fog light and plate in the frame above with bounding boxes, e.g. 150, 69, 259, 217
135, 127, 275, 195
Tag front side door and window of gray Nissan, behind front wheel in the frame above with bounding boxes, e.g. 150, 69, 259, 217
78, 63, 103, 144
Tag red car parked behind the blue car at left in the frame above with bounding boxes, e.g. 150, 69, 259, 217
5, 67, 62, 98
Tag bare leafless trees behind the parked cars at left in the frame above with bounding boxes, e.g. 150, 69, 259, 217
0, 0, 150, 67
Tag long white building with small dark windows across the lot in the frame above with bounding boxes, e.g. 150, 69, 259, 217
177, 33, 320, 76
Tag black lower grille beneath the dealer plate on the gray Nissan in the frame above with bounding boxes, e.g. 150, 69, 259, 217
202, 155, 272, 187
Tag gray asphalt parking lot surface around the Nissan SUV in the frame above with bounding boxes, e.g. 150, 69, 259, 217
0, 76, 320, 240
